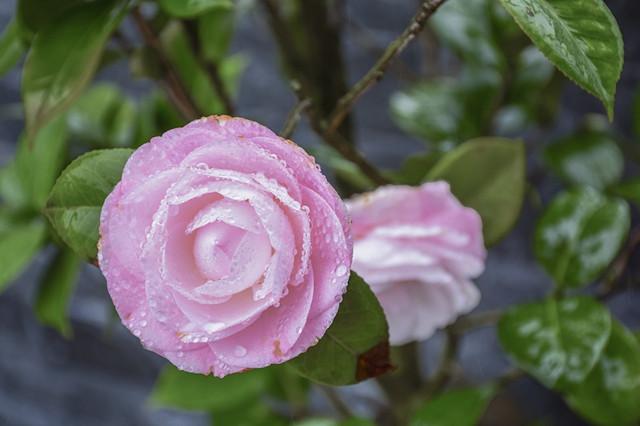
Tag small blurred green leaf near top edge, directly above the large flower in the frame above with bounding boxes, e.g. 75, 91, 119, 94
198, 8, 234, 62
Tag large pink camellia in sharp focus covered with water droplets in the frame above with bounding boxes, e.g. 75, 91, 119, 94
98, 116, 352, 377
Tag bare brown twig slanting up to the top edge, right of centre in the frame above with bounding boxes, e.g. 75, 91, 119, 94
327, 0, 445, 134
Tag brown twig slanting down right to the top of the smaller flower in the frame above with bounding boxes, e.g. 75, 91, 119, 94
292, 82, 389, 185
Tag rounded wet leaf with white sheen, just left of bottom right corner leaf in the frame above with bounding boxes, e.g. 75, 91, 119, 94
498, 296, 611, 389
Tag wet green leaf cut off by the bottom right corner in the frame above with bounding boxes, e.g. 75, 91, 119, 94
567, 321, 640, 426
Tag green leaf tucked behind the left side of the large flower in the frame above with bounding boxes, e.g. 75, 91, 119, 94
44, 148, 133, 260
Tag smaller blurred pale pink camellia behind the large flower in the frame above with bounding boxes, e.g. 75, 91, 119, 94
347, 182, 486, 345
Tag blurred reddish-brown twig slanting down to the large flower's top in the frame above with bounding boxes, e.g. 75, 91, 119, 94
132, 7, 201, 120
